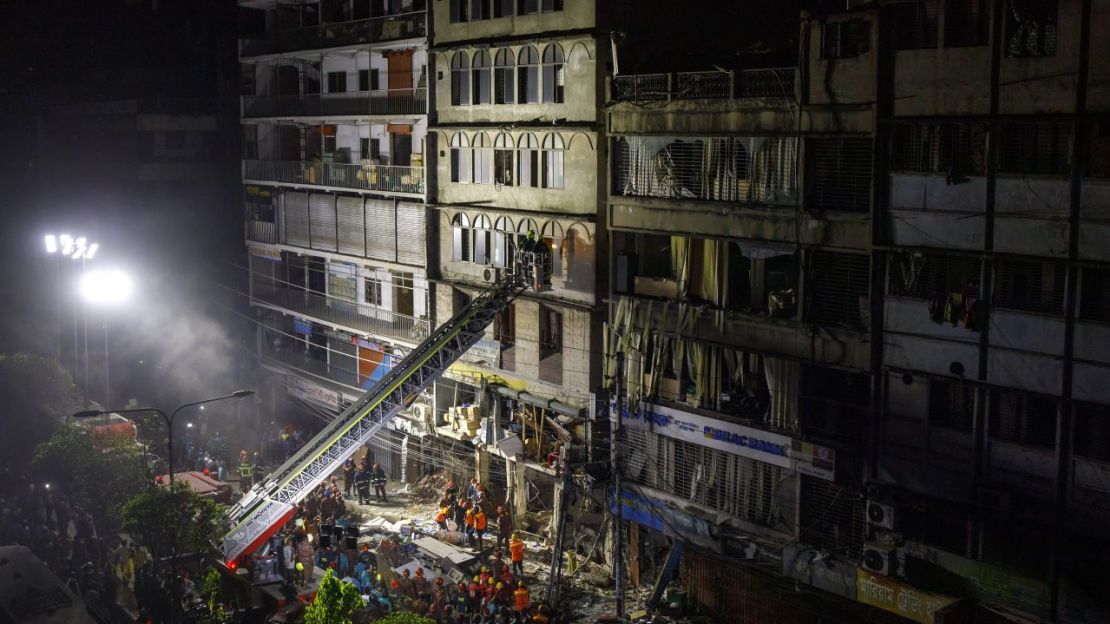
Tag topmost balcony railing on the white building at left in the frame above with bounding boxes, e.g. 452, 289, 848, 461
239, 11, 427, 57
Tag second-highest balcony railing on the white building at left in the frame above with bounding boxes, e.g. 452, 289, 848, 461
243, 89, 427, 118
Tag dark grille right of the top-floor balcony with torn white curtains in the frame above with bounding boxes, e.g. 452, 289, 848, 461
808, 137, 872, 212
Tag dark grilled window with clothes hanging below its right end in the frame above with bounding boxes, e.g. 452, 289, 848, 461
888, 253, 981, 300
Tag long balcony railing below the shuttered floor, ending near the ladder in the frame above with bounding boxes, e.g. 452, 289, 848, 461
251, 273, 428, 342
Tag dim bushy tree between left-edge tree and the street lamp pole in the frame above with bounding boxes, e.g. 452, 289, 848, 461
31, 424, 150, 524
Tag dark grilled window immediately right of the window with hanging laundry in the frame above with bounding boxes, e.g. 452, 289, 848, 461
991, 260, 1067, 314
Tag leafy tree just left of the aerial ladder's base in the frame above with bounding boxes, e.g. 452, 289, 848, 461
120, 481, 223, 560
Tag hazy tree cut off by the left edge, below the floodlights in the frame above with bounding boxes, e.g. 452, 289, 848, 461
0, 353, 81, 462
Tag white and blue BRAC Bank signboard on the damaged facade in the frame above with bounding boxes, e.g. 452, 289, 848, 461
626, 402, 836, 481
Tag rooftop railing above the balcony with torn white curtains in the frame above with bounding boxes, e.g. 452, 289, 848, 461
612, 68, 795, 102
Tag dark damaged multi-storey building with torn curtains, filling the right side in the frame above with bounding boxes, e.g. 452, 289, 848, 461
606, 0, 1110, 623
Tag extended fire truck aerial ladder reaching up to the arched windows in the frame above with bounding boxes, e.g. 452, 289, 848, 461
222, 246, 551, 565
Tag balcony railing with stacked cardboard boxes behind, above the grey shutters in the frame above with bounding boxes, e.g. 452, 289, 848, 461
243, 160, 424, 195
